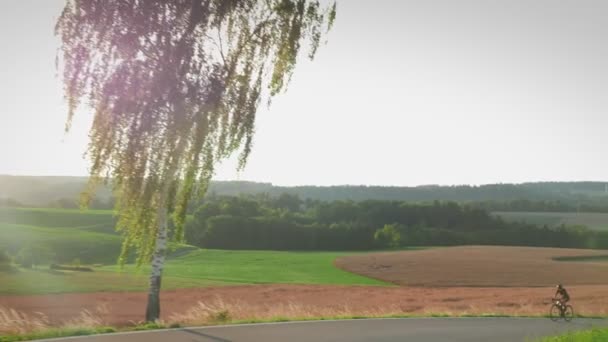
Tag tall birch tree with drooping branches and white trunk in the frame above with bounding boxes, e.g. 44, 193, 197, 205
56, 0, 336, 321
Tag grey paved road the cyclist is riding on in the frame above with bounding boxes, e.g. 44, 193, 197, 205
40, 318, 608, 342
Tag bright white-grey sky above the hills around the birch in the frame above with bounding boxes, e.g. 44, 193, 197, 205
0, 0, 608, 185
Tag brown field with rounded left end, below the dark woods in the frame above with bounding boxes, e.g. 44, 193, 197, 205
335, 246, 608, 287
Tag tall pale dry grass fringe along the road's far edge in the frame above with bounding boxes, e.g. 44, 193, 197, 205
0, 296, 608, 335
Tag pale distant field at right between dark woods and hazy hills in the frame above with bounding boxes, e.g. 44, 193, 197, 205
493, 212, 608, 230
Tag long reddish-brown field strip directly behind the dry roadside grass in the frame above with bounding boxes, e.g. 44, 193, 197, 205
0, 285, 608, 326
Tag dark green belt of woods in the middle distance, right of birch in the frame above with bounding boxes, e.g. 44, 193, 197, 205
186, 194, 608, 250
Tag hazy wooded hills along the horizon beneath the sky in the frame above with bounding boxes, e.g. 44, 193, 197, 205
0, 175, 608, 212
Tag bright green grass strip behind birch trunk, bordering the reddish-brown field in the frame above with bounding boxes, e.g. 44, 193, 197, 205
0, 250, 386, 295
